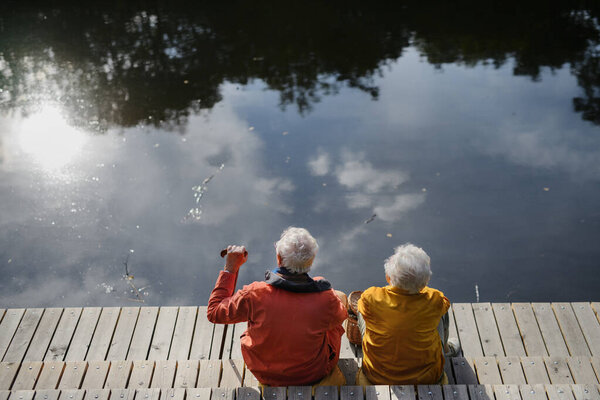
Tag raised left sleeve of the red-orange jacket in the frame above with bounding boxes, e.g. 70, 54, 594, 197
206, 271, 250, 324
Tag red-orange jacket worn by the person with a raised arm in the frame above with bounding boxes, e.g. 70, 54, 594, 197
207, 271, 348, 386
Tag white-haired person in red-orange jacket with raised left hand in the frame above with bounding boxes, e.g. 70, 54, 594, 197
207, 227, 348, 386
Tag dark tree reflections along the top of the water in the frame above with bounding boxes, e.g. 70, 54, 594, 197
0, 0, 600, 131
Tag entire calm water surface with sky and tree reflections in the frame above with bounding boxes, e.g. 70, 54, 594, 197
0, 0, 600, 307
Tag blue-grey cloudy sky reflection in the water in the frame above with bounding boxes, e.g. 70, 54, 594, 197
0, 41, 600, 307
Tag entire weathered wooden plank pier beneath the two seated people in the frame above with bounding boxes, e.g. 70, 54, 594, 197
0, 302, 600, 400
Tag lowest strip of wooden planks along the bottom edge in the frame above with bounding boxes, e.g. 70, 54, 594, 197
0, 384, 600, 400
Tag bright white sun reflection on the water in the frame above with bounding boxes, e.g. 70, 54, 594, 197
18, 106, 86, 170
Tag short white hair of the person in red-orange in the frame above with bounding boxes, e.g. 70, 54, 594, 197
275, 226, 319, 274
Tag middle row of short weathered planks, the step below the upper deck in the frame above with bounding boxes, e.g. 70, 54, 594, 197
0, 356, 600, 388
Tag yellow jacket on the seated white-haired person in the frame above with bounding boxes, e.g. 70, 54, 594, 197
358, 285, 450, 385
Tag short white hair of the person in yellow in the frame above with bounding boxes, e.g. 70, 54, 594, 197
384, 243, 431, 293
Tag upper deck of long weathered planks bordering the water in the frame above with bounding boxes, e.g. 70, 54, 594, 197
0, 302, 600, 362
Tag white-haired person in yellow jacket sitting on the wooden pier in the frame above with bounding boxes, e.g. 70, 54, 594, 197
357, 243, 459, 386
